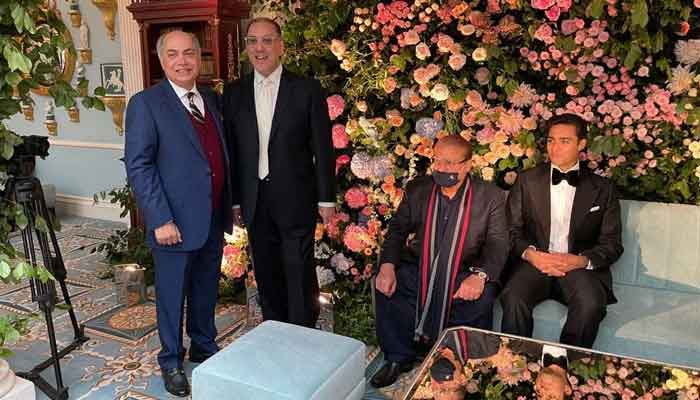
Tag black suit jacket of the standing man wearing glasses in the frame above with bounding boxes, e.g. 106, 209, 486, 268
223, 70, 336, 229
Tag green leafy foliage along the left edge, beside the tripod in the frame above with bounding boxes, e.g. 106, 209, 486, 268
0, 0, 104, 357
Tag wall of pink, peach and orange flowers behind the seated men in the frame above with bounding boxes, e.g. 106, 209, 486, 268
250, 0, 700, 340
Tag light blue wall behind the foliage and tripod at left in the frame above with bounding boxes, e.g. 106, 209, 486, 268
6, 0, 125, 198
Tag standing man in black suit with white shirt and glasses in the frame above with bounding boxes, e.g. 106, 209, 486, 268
223, 18, 336, 327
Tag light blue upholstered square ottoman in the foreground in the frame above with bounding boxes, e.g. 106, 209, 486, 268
192, 321, 365, 400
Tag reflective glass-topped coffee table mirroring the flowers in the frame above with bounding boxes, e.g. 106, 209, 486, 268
404, 327, 700, 400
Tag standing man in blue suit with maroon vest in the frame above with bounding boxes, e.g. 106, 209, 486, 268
125, 31, 233, 396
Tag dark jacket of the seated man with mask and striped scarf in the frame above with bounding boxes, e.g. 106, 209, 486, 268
381, 176, 509, 281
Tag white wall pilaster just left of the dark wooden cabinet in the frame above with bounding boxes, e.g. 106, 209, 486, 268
117, 0, 143, 101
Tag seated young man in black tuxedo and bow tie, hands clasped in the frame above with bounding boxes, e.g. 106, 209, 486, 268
501, 114, 623, 348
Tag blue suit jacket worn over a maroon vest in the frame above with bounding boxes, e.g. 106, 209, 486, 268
124, 79, 233, 251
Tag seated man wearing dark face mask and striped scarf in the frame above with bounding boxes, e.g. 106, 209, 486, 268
372, 135, 509, 387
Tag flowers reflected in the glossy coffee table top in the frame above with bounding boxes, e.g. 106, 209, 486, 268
412, 346, 700, 400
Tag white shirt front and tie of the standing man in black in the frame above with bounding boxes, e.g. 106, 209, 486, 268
253, 64, 282, 179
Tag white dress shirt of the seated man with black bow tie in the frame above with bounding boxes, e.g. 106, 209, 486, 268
549, 163, 579, 253
